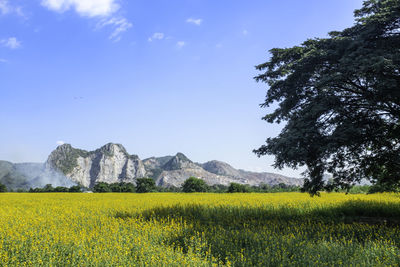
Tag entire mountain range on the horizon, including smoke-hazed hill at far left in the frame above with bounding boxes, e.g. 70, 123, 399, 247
0, 143, 303, 189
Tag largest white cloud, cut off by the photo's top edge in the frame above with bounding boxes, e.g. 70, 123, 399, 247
42, 0, 120, 17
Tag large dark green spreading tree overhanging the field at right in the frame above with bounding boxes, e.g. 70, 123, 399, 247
254, 0, 400, 197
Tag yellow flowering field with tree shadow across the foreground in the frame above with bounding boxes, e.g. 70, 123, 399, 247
0, 193, 400, 266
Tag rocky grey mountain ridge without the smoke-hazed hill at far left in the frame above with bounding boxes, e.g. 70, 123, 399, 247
46, 143, 303, 187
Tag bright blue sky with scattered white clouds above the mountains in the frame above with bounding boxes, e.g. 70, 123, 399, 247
0, 0, 362, 177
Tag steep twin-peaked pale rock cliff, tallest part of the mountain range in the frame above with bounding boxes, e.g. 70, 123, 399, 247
46, 143, 146, 187
